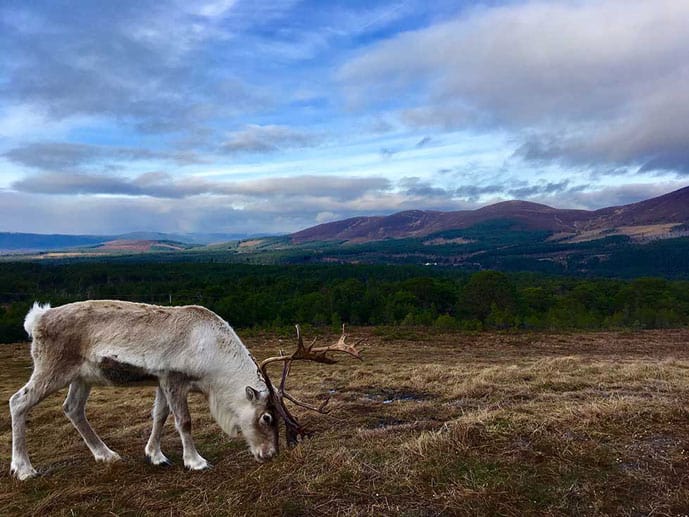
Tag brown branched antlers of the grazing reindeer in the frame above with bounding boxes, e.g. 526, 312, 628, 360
259, 325, 363, 447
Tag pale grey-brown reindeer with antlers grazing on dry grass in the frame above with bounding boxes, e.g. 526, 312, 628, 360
10, 300, 361, 480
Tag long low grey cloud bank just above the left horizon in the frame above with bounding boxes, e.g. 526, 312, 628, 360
0, 177, 448, 234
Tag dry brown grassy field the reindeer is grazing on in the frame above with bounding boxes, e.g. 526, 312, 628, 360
0, 328, 689, 516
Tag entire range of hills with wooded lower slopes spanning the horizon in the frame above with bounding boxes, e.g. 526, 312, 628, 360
0, 188, 689, 280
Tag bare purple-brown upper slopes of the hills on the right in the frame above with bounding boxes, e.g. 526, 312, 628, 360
290, 187, 689, 244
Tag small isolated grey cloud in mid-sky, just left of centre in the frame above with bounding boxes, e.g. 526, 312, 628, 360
222, 124, 320, 153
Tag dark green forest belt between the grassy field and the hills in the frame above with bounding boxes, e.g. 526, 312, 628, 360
0, 262, 689, 343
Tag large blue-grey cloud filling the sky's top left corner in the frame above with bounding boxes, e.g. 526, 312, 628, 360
0, 0, 271, 133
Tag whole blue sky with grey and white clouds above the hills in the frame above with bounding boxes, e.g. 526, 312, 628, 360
0, 0, 689, 234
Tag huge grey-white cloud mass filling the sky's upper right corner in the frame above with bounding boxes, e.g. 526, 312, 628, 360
338, 0, 689, 173
